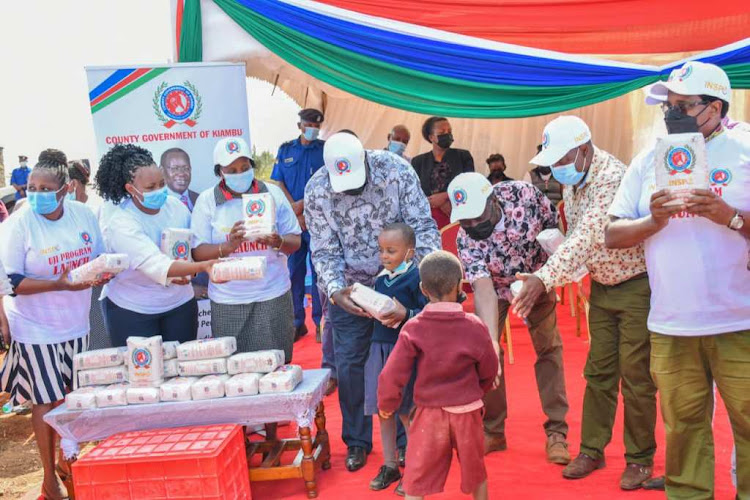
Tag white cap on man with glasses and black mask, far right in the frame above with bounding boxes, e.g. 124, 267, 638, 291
646, 61, 732, 104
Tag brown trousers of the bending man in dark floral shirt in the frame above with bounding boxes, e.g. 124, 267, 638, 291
484, 292, 568, 436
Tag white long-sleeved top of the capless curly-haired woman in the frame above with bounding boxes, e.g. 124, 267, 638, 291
100, 196, 195, 312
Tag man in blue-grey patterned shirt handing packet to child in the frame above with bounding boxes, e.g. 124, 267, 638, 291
305, 133, 440, 471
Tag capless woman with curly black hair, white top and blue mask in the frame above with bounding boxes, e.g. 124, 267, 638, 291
96, 144, 213, 346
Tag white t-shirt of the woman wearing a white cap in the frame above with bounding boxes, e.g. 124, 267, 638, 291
191, 183, 302, 304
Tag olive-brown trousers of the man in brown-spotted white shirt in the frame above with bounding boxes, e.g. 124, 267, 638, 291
581, 275, 656, 466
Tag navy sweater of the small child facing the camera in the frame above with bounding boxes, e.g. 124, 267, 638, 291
372, 262, 428, 344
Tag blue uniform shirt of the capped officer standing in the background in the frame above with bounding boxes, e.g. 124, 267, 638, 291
271, 137, 325, 201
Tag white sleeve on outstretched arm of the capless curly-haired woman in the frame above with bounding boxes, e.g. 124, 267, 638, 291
105, 211, 174, 286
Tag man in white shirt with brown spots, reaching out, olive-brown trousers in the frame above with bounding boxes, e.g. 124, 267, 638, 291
513, 116, 656, 490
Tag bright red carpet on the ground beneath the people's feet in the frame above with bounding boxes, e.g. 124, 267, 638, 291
252, 296, 735, 500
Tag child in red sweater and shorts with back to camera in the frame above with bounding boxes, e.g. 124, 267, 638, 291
378, 251, 498, 499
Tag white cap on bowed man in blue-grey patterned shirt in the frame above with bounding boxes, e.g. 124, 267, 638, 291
323, 132, 367, 193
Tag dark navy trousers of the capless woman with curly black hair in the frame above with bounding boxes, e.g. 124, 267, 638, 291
102, 299, 198, 347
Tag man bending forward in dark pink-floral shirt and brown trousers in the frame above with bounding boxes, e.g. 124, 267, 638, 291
448, 173, 570, 465
